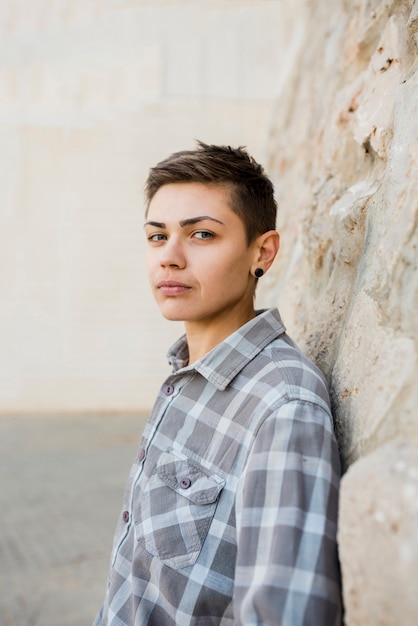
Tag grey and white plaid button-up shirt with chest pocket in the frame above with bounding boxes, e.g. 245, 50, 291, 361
94, 309, 341, 626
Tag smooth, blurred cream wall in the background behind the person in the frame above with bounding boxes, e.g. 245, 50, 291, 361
0, 0, 289, 413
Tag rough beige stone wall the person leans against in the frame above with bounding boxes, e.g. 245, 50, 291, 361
262, 0, 418, 626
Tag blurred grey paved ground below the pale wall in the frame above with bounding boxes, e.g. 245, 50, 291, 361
0, 416, 148, 626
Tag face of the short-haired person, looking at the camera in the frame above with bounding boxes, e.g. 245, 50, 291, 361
145, 183, 257, 328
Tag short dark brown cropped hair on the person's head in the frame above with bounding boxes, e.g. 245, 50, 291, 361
145, 141, 277, 244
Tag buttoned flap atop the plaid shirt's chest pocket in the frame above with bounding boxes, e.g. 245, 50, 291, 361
157, 450, 225, 504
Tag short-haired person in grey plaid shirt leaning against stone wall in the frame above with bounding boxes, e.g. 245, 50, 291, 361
95, 143, 341, 626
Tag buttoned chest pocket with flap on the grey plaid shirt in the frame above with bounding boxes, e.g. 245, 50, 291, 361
135, 450, 225, 569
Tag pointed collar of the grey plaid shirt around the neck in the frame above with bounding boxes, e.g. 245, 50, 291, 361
167, 309, 286, 390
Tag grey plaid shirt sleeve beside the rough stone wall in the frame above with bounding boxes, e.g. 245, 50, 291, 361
234, 401, 342, 626
